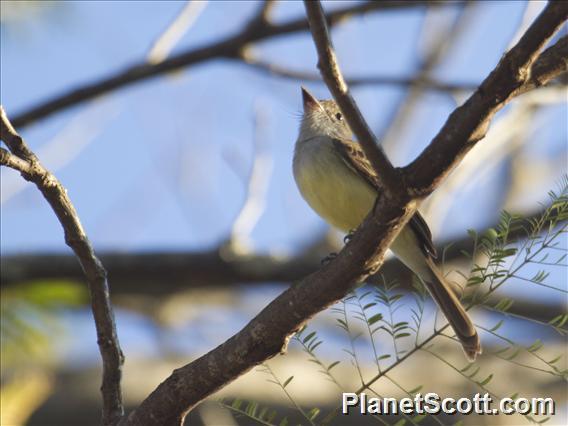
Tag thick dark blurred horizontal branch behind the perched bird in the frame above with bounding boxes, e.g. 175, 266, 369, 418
0, 206, 550, 297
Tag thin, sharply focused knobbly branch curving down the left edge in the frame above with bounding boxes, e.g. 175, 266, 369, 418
0, 106, 124, 426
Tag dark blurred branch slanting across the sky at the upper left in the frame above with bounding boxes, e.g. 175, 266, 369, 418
12, 0, 445, 127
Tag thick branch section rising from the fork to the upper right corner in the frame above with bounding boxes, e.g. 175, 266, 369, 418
402, 2, 568, 197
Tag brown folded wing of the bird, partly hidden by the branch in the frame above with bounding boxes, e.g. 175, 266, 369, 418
333, 138, 437, 258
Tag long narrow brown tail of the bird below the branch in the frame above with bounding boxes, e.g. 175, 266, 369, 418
422, 258, 481, 361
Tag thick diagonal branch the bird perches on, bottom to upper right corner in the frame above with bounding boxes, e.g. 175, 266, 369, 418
117, 2, 568, 425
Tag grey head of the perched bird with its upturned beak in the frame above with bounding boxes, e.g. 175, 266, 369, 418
298, 87, 352, 140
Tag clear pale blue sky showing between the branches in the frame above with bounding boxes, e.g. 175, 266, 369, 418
0, 1, 567, 380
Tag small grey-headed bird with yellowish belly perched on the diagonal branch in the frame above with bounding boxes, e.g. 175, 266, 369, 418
293, 87, 481, 361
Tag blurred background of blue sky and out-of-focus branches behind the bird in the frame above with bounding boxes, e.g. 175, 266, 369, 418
0, 1, 568, 425
